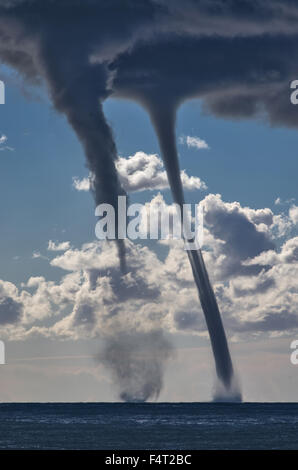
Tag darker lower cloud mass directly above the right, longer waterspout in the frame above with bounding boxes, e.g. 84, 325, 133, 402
111, 34, 298, 126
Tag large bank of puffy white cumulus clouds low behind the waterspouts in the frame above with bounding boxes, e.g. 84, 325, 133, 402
0, 194, 298, 340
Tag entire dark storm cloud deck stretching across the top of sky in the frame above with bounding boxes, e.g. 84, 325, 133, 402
0, 0, 298, 126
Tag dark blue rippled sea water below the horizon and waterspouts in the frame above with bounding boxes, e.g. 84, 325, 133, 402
0, 403, 298, 450
